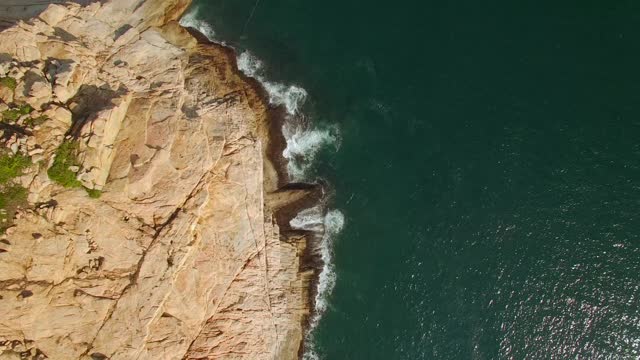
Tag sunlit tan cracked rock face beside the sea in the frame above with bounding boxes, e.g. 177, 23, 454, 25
0, 0, 310, 359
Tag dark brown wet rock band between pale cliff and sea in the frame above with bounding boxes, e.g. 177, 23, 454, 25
180, 23, 326, 359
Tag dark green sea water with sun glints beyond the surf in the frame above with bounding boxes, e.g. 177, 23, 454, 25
184, 0, 640, 359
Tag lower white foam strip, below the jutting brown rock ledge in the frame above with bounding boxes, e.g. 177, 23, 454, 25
289, 205, 344, 360
